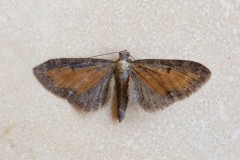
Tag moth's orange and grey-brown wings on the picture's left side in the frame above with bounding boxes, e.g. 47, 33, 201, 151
33, 58, 114, 110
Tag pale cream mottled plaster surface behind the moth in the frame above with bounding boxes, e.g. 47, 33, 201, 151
0, 0, 240, 160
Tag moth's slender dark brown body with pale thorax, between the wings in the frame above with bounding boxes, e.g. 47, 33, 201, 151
115, 60, 129, 122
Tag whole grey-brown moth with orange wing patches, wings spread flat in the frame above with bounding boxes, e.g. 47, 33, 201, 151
33, 50, 211, 122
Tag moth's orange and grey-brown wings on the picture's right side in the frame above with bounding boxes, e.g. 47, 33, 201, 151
130, 59, 211, 110
